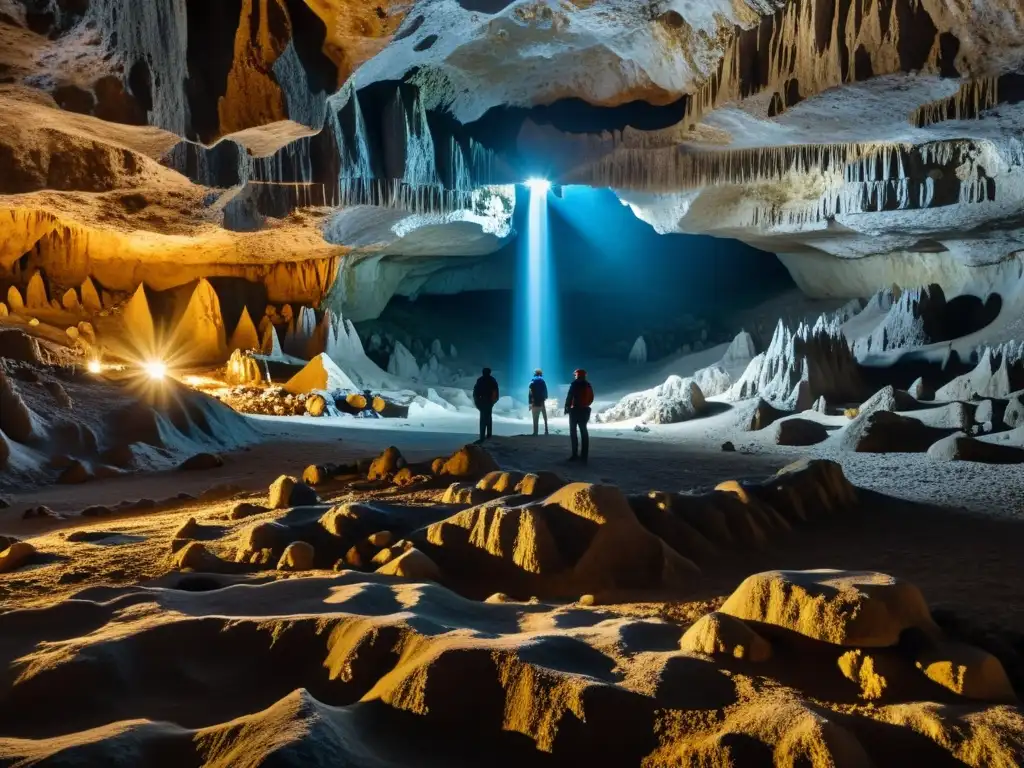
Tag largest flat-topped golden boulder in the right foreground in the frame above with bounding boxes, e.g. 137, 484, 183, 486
721, 570, 938, 648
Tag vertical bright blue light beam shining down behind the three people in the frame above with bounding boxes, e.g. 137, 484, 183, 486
509, 183, 560, 397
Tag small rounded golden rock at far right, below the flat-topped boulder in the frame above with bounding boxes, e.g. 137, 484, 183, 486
916, 641, 1017, 702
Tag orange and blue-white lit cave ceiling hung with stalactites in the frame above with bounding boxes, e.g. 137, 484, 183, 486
0, 0, 1024, 316
